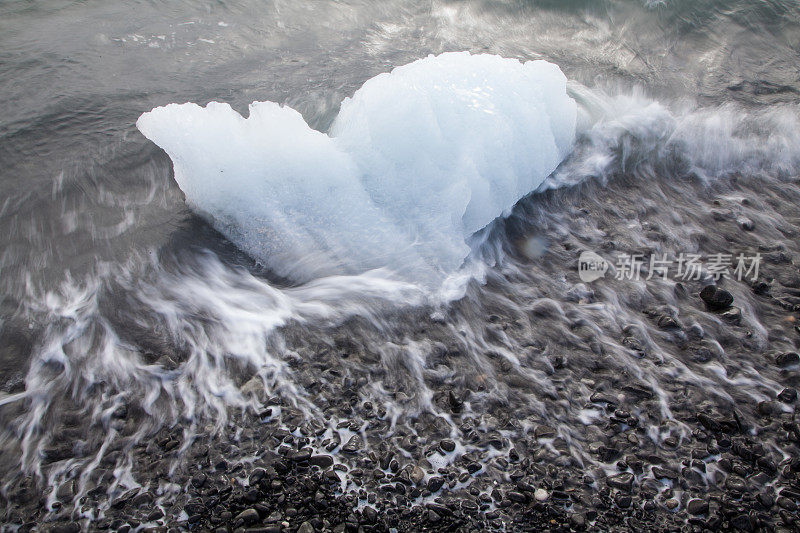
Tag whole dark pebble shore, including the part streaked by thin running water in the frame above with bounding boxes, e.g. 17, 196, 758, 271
2, 166, 800, 533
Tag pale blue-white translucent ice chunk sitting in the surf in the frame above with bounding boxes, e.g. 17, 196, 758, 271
137, 52, 576, 281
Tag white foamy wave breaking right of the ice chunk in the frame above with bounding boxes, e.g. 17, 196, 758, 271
542, 83, 800, 188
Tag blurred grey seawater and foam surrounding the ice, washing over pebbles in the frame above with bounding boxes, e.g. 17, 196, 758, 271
0, 0, 800, 523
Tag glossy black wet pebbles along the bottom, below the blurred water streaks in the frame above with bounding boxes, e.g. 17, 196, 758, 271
4, 330, 800, 533
